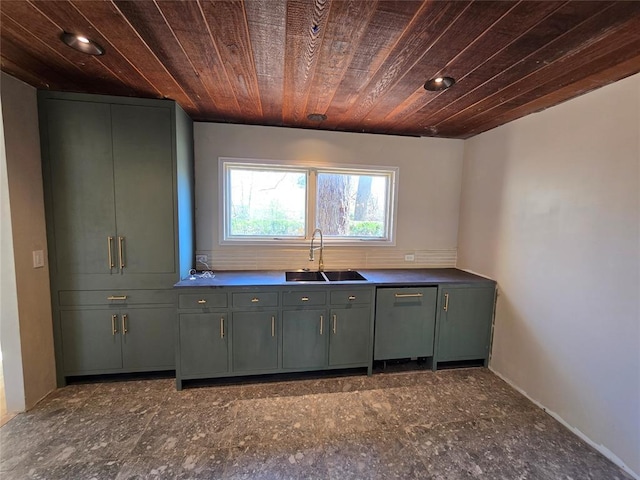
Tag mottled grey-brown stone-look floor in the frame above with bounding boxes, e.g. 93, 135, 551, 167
0, 368, 631, 480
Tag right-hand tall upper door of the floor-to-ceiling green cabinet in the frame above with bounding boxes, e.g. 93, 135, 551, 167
111, 105, 175, 274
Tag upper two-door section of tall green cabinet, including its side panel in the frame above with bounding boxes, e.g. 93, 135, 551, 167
39, 92, 193, 290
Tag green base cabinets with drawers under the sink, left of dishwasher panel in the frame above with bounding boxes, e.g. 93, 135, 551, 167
176, 286, 374, 389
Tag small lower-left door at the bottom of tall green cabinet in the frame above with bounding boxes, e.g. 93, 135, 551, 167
60, 309, 122, 375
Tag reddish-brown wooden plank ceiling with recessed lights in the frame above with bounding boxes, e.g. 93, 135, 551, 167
0, 0, 640, 138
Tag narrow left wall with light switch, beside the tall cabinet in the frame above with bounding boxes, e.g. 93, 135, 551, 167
0, 74, 56, 411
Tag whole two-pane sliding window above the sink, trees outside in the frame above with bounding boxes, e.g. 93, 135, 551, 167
220, 158, 397, 244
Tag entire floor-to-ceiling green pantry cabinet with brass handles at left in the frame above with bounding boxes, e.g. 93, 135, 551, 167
38, 91, 194, 384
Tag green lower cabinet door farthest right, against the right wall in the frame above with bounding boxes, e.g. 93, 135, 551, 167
437, 287, 495, 361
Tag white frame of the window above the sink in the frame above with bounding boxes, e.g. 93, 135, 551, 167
218, 157, 399, 247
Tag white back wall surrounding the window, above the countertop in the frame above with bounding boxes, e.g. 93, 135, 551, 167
194, 123, 463, 269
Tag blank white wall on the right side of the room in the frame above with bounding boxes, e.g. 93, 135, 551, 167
458, 75, 640, 473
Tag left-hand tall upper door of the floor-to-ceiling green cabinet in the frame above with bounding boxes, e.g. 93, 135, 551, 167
42, 99, 116, 276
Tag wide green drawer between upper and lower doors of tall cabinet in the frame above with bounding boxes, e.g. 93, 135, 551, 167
58, 290, 176, 307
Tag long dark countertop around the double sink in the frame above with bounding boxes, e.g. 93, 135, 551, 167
174, 268, 495, 288
